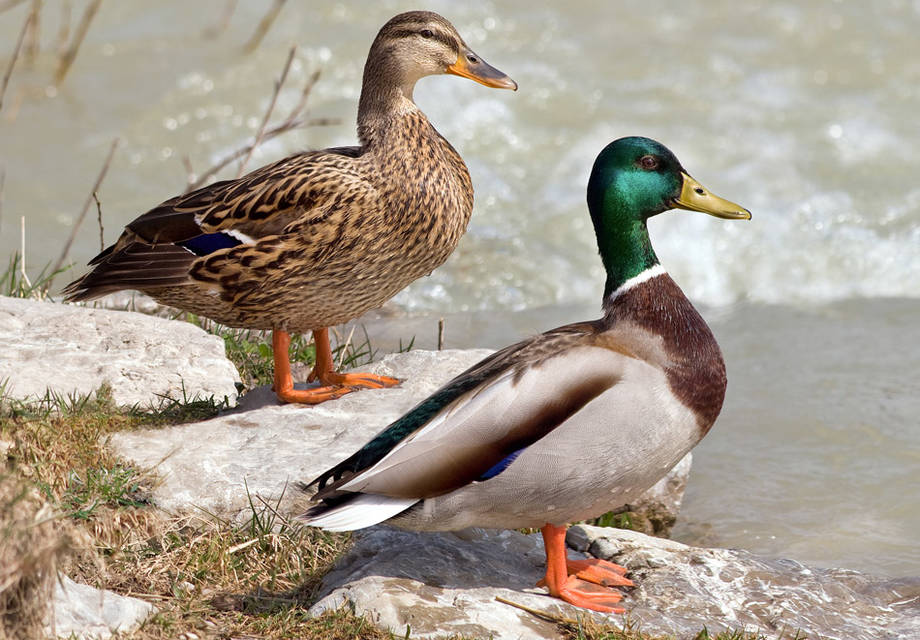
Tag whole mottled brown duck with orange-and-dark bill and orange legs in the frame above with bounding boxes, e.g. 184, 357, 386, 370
64, 11, 517, 404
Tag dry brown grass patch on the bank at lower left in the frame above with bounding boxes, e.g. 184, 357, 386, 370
0, 390, 410, 640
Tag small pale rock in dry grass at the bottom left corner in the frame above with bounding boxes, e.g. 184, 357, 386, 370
45, 576, 156, 639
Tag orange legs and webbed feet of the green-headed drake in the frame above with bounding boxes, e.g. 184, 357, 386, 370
540, 524, 632, 613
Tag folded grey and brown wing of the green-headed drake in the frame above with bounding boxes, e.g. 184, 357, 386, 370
308, 323, 630, 504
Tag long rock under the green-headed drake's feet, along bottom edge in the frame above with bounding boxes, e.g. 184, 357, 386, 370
310, 526, 920, 640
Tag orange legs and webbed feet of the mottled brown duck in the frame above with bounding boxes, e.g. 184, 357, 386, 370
272, 329, 399, 404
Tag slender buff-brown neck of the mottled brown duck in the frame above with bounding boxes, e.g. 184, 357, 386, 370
358, 50, 421, 146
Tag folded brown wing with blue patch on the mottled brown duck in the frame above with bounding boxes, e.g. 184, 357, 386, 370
64, 147, 366, 300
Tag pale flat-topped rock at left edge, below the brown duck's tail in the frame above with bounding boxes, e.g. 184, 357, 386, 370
0, 296, 239, 407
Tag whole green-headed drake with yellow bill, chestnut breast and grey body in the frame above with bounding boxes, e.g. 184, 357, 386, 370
303, 138, 751, 611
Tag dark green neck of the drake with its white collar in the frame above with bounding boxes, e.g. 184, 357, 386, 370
588, 186, 663, 299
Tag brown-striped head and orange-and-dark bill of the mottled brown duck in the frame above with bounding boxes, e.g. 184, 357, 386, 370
364, 11, 517, 99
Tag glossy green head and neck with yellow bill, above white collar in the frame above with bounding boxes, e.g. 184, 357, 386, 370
588, 137, 751, 296
